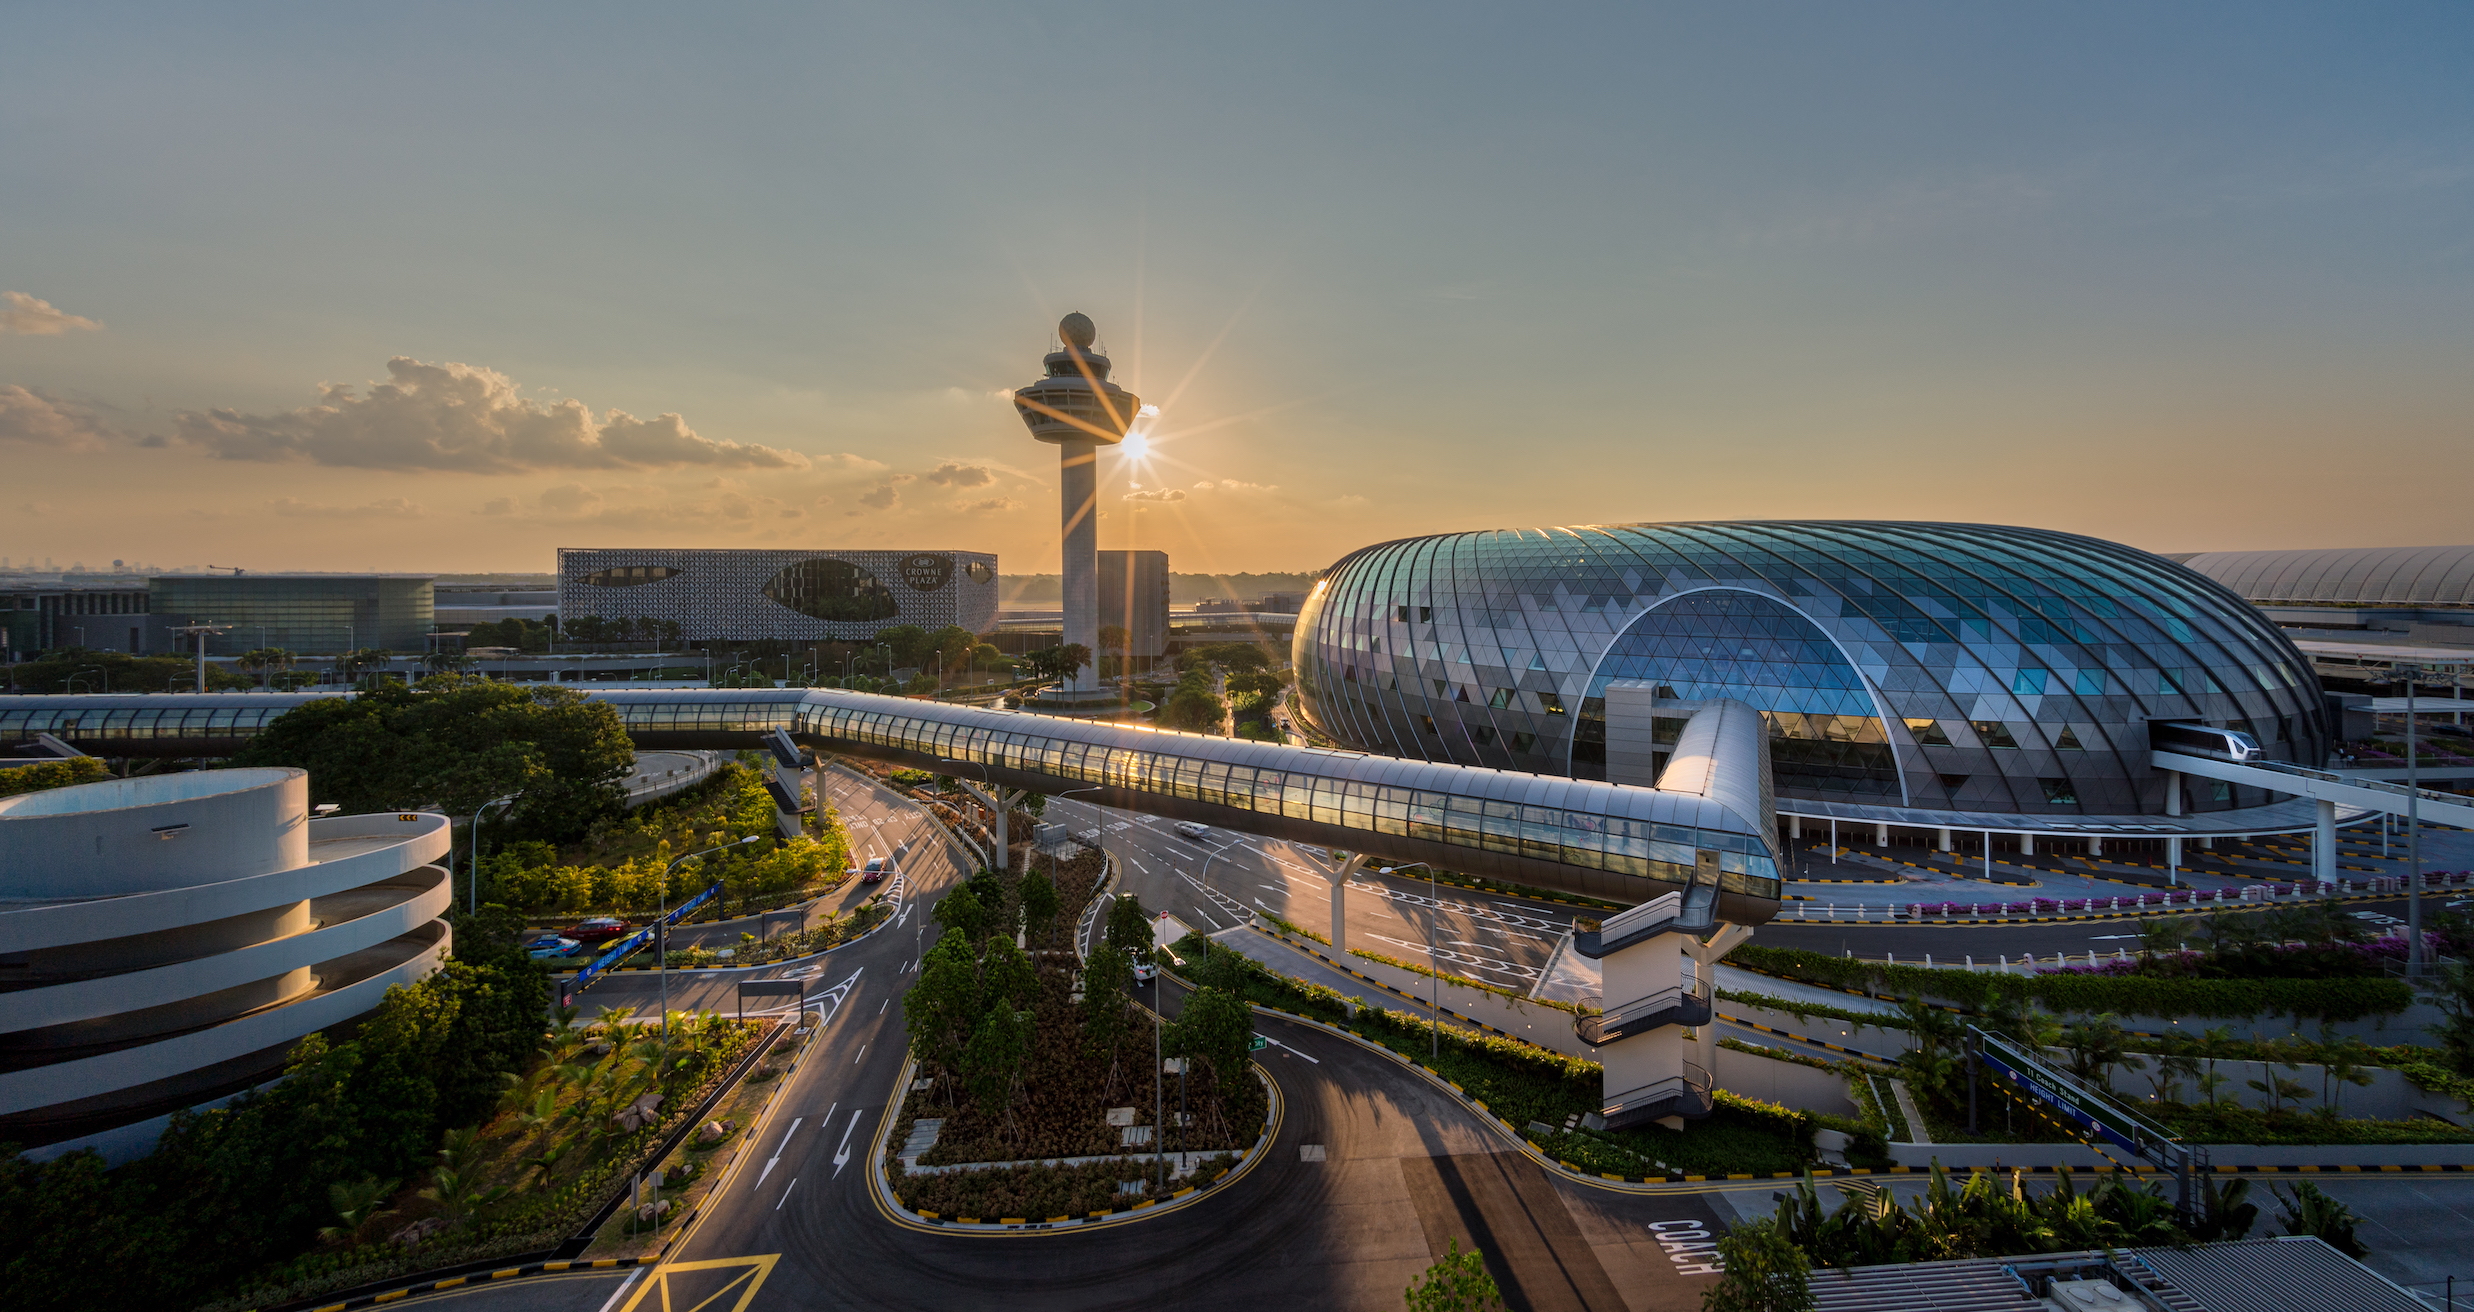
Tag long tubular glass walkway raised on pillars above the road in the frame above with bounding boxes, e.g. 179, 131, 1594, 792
0, 688, 1779, 926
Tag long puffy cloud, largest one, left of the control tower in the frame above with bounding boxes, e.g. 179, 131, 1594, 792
178, 356, 807, 473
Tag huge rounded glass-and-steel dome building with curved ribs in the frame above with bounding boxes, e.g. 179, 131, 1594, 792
1294, 520, 2331, 819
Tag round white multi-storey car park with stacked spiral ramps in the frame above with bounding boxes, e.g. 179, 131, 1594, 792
0, 767, 450, 1151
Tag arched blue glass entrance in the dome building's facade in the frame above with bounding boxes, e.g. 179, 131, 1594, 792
1569, 587, 1907, 805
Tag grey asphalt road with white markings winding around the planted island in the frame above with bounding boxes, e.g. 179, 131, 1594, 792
406, 780, 2467, 1312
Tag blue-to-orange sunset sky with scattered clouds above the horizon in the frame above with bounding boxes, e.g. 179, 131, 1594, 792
0, 2, 2474, 574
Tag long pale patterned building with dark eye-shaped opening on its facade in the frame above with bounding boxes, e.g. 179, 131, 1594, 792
559, 547, 997, 644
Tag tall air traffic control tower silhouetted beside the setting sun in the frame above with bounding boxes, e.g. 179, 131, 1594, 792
1014, 314, 1143, 710
